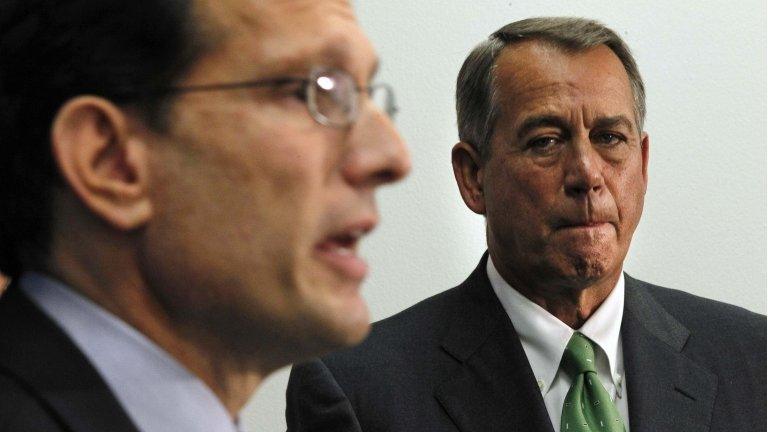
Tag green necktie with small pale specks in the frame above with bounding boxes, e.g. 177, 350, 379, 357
560, 332, 624, 432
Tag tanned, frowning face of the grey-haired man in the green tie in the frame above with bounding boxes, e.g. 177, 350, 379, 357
482, 41, 648, 289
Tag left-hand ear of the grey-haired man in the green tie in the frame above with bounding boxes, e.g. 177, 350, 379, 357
451, 142, 485, 215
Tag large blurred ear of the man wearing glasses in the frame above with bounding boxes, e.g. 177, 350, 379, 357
51, 96, 152, 231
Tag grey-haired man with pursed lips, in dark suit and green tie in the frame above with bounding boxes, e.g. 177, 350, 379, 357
287, 18, 766, 432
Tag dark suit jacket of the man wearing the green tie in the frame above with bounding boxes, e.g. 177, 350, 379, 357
286, 258, 766, 432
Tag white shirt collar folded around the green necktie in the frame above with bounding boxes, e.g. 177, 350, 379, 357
486, 257, 624, 390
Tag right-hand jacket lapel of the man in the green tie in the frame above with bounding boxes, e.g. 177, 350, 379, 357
621, 276, 717, 432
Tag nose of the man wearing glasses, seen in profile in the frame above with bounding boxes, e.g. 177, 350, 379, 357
343, 104, 411, 187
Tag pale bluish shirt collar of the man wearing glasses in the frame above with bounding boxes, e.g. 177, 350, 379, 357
19, 273, 242, 432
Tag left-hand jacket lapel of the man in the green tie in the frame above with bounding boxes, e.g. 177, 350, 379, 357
435, 254, 552, 432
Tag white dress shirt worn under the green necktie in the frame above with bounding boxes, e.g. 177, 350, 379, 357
487, 257, 629, 432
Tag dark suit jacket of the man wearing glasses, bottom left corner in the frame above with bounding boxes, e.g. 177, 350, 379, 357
0, 284, 137, 432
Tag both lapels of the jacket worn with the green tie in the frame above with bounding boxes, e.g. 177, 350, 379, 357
435, 253, 717, 432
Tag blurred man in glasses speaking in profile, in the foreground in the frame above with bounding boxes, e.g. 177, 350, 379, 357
0, 0, 409, 432
